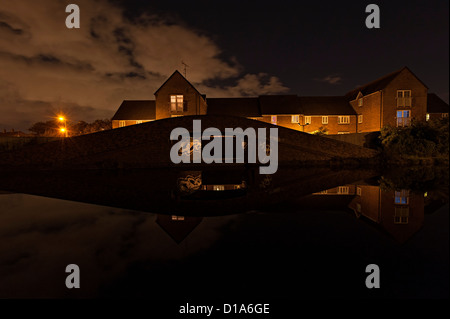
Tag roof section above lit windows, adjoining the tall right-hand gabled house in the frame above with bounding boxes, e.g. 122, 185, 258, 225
299, 96, 356, 115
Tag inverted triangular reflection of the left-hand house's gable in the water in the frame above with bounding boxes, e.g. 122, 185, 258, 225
156, 215, 203, 244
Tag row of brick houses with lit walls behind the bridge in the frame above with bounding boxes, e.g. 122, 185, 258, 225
112, 67, 449, 134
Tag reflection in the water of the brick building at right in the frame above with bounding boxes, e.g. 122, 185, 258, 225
314, 184, 424, 243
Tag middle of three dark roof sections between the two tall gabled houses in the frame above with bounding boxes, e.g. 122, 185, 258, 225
259, 95, 302, 115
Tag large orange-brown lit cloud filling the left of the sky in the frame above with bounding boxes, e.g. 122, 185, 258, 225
0, 0, 288, 130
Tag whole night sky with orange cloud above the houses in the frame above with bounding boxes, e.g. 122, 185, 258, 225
0, 0, 449, 131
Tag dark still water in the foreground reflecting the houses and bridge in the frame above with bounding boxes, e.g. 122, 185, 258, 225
0, 168, 449, 301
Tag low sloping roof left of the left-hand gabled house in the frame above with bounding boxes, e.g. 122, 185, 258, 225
112, 100, 156, 120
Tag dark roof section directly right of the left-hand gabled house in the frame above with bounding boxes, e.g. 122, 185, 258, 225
206, 97, 261, 117
